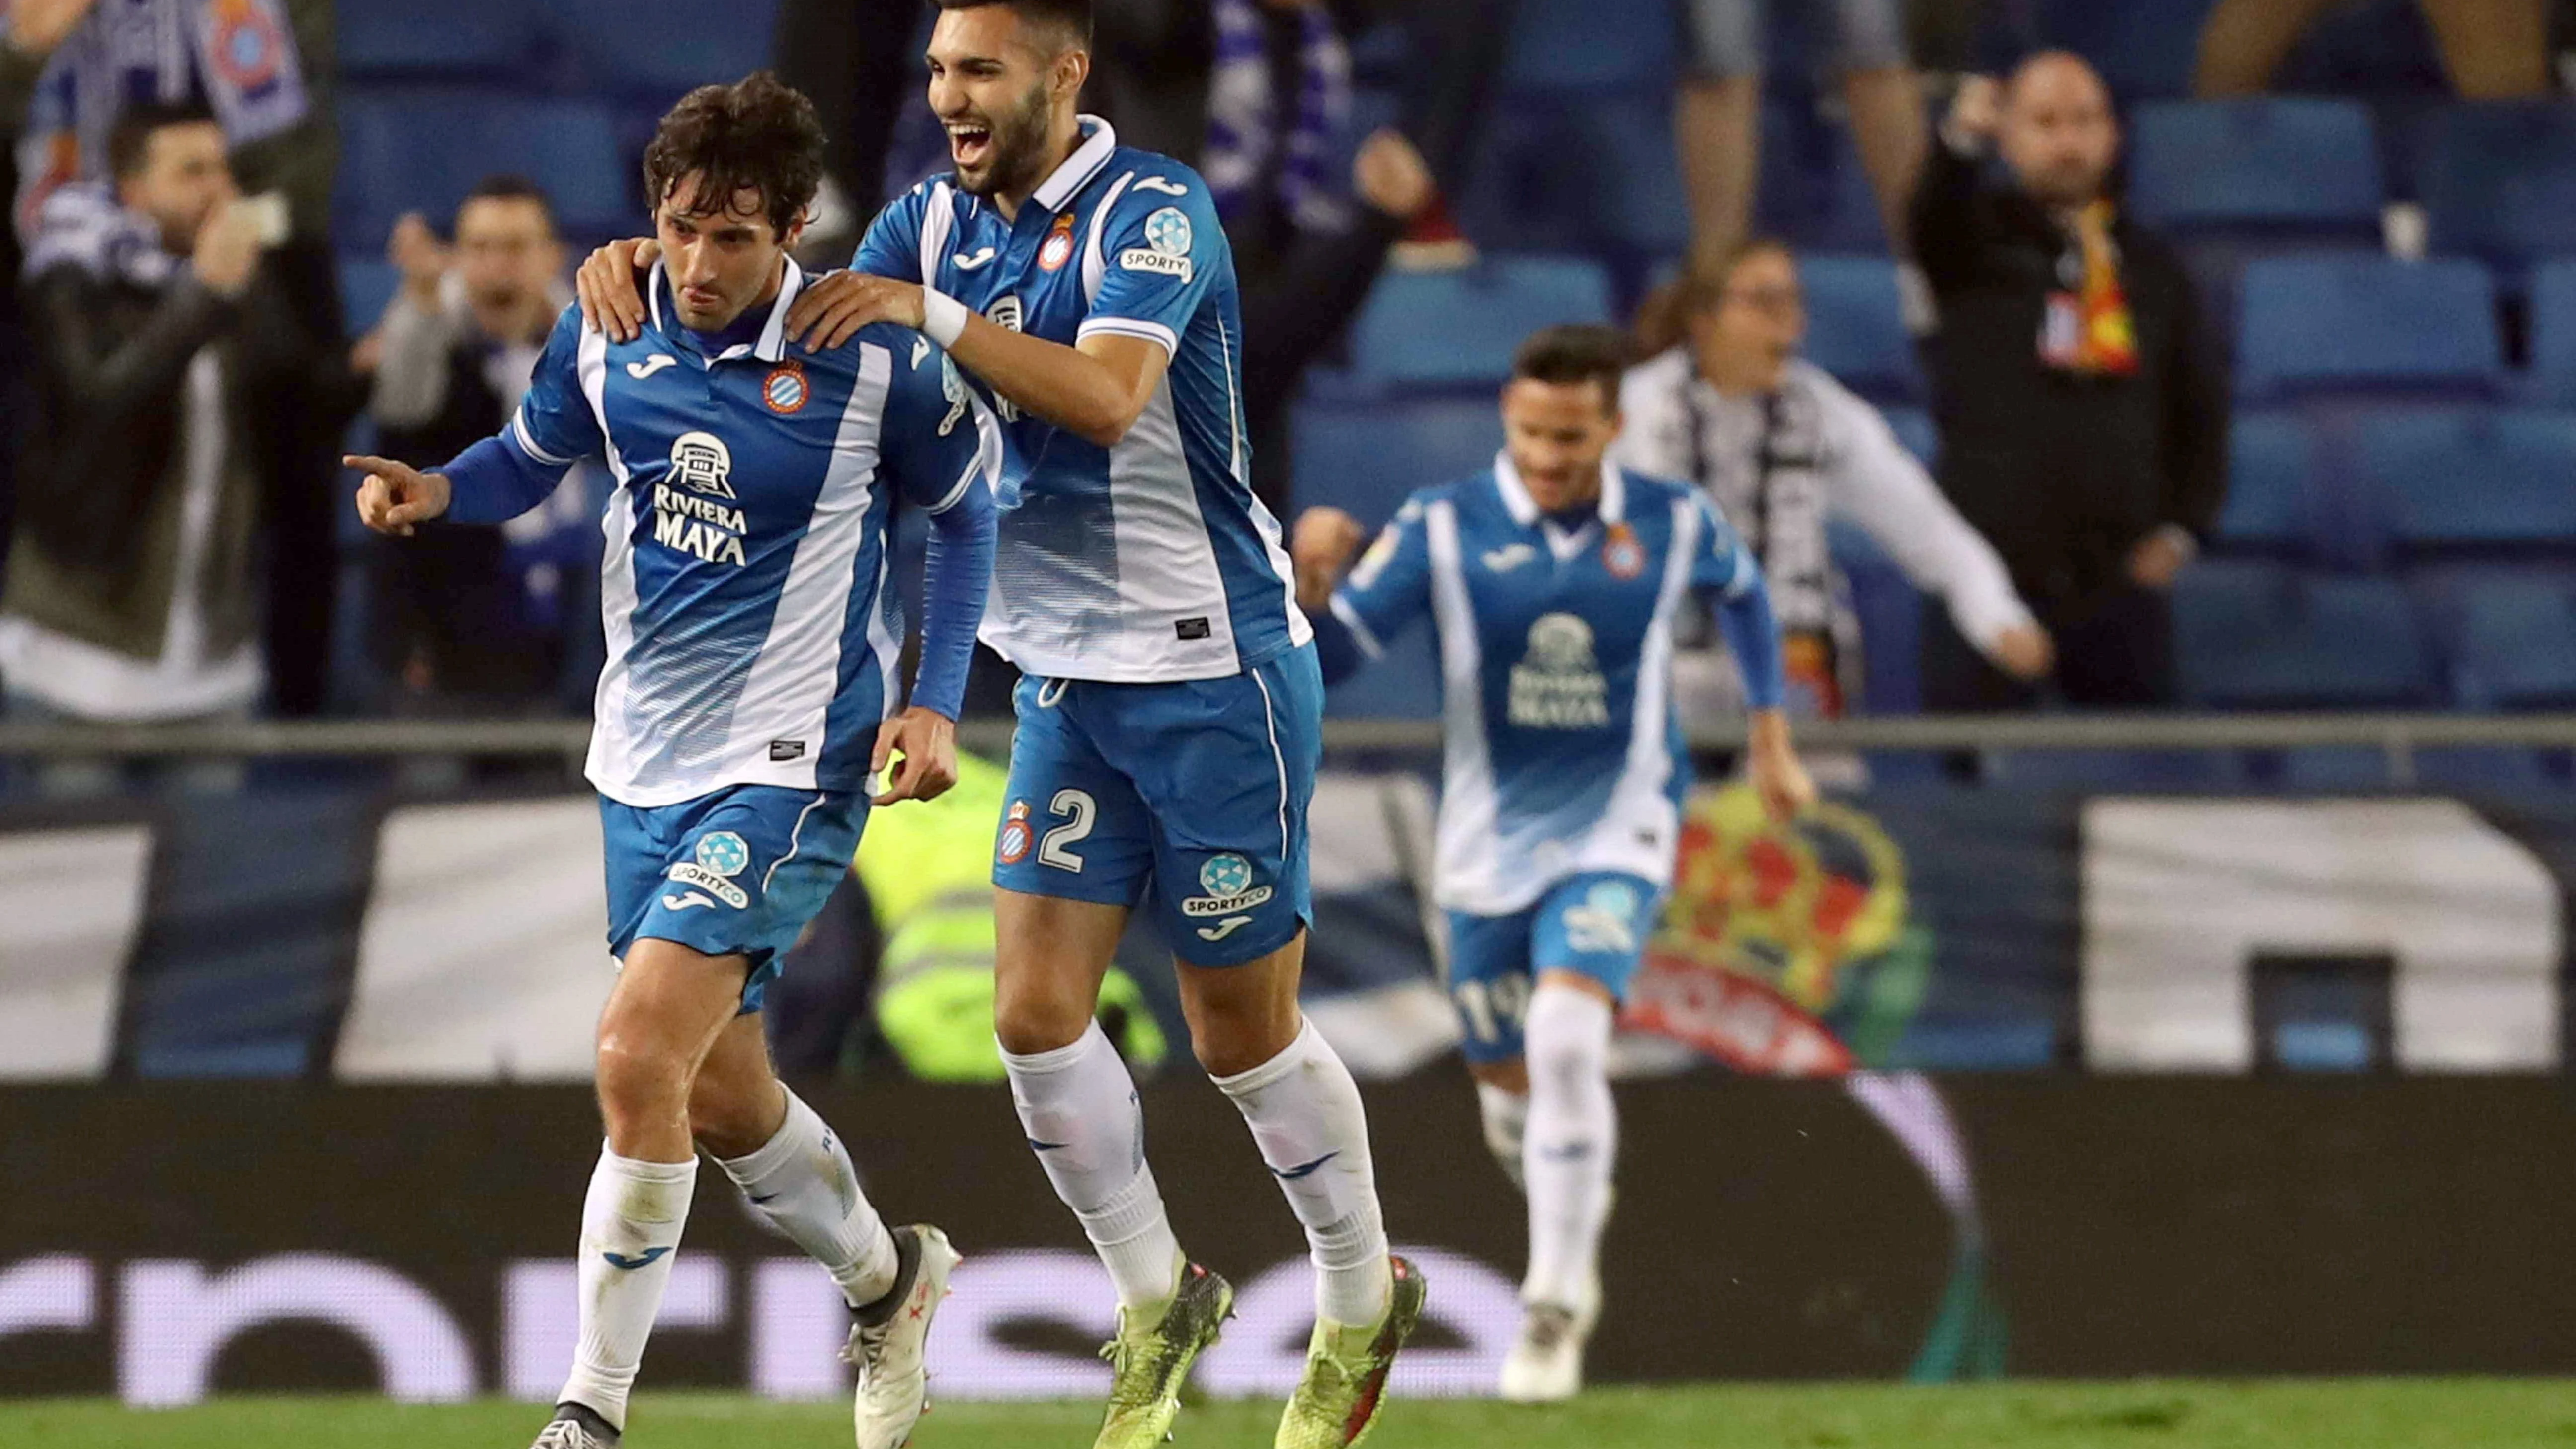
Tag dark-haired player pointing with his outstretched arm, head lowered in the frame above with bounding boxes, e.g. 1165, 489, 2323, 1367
350, 72, 1002, 1449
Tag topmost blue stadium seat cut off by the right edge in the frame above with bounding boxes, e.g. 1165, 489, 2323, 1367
2424, 103, 2576, 268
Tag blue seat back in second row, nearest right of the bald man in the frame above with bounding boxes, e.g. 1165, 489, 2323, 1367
2236, 252, 2504, 400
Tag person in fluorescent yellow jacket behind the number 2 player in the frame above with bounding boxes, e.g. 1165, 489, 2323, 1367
853, 750, 1167, 1083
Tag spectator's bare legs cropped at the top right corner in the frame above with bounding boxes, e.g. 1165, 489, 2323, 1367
2192, 0, 2550, 100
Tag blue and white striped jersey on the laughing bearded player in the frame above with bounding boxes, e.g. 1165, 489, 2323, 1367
853, 116, 1311, 683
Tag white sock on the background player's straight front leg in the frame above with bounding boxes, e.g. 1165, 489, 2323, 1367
1520, 985, 1618, 1312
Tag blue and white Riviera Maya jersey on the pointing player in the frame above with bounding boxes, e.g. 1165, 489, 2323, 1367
502, 263, 1002, 807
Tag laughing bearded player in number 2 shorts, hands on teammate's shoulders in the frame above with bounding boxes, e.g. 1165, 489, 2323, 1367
582, 0, 1422, 1449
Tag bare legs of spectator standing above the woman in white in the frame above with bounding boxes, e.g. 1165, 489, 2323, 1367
1675, 0, 1924, 271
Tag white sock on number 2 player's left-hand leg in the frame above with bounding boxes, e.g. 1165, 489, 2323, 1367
1002, 1021, 1182, 1307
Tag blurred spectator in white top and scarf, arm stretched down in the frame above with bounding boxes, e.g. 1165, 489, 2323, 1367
1615, 240, 2050, 717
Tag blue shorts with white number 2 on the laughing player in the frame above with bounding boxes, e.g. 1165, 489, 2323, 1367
992, 644, 1324, 967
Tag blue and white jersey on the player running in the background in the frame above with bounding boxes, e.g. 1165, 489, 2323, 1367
1332, 456, 1762, 915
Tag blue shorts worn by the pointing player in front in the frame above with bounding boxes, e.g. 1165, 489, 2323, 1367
600, 784, 868, 1013
